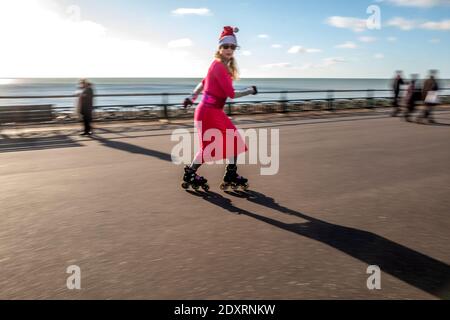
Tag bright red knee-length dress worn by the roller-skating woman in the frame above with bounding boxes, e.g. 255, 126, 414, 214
194, 60, 248, 163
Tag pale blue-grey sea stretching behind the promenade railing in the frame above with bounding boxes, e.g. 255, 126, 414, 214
0, 78, 450, 111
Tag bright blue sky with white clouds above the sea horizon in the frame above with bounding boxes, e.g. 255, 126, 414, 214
0, 0, 450, 82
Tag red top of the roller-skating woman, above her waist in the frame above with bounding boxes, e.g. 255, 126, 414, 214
203, 60, 234, 99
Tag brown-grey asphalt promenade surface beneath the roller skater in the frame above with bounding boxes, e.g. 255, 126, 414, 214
0, 112, 450, 299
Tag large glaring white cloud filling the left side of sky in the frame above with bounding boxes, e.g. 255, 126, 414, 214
0, 0, 207, 78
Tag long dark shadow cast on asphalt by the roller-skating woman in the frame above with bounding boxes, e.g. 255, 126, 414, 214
192, 191, 450, 299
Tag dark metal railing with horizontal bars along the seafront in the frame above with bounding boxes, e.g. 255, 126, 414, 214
0, 88, 450, 124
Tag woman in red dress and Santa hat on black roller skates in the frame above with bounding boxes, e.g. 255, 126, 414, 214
182, 27, 258, 191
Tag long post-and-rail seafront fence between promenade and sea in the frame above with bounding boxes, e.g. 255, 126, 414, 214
0, 88, 450, 125
